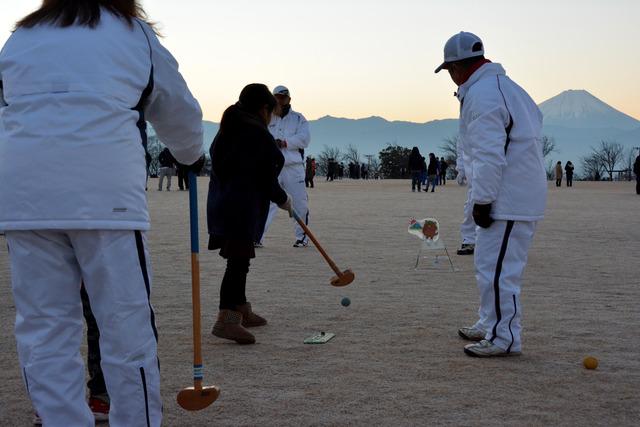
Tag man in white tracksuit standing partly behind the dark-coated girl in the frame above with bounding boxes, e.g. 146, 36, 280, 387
256, 86, 311, 248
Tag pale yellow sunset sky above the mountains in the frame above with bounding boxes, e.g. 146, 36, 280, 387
0, 0, 640, 122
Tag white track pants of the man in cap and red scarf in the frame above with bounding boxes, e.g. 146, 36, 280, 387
475, 221, 536, 351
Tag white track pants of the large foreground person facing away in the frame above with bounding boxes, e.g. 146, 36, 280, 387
6, 230, 162, 427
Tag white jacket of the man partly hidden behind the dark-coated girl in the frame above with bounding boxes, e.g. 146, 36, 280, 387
269, 110, 311, 166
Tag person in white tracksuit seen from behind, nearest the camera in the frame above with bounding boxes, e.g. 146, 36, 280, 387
0, 0, 204, 427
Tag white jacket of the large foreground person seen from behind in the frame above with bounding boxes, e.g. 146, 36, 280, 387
0, 10, 204, 230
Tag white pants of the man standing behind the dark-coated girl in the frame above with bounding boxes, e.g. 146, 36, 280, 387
262, 164, 309, 241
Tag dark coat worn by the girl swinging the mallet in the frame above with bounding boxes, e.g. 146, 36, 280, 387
207, 106, 287, 242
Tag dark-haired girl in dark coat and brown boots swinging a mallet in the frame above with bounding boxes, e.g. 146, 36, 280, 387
207, 83, 292, 344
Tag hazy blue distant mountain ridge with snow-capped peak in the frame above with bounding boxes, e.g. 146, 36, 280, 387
156, 90, 640, 168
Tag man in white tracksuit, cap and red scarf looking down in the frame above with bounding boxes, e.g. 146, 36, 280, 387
436, 32, 547, 357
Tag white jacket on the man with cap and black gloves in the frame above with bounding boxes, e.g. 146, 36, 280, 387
457, 63, 547, 221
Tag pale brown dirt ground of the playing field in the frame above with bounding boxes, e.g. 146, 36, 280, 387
0, 178, 640, 426
